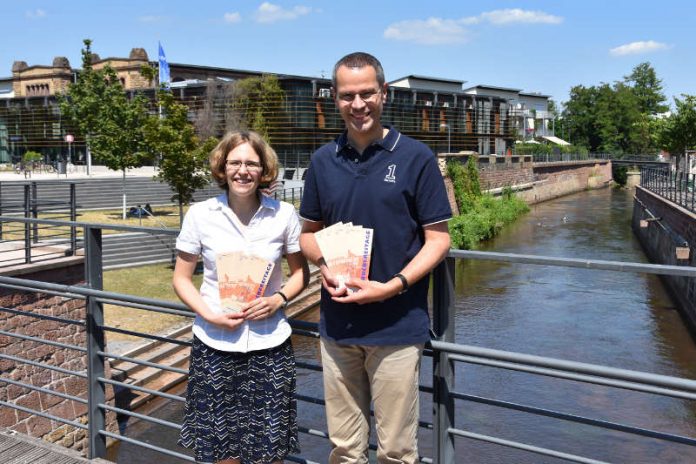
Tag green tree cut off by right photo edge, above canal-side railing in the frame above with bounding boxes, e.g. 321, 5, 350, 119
659, 94, 696, 166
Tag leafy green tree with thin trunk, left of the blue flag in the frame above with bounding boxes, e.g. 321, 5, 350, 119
58, 39, 154, 219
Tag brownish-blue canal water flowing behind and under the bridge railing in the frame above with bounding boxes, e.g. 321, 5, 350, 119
110, 189, 696, 464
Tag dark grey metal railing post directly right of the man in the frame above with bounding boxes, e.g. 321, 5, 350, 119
433, 258, 455, 464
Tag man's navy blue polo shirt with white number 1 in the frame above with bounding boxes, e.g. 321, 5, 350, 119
300, 128, 452, 345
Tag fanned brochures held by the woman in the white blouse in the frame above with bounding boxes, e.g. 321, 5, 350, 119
215, 251, 275, 313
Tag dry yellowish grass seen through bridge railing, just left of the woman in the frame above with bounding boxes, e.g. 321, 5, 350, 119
104, 264, 203, 342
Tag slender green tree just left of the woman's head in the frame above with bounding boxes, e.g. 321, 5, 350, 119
145, 89, 217, 223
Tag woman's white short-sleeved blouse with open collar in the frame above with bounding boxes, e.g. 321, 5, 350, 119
176, 193, 300, 353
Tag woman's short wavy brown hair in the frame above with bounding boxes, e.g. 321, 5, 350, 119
210, 131, 278, 190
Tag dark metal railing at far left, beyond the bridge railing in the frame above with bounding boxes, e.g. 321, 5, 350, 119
0, 182, 78, 267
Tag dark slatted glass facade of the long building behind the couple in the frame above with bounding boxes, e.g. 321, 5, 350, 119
0, 70, 514, 168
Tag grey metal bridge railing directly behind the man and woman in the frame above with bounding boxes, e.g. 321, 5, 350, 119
0, 219, 696, 464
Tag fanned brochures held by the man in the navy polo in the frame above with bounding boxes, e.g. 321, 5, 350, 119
314, 222, 374, 291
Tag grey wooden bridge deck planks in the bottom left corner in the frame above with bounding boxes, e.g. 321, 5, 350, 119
0, 429, 113, 464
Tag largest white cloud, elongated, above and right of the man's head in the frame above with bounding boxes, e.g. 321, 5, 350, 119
384, 8, 563, 45
